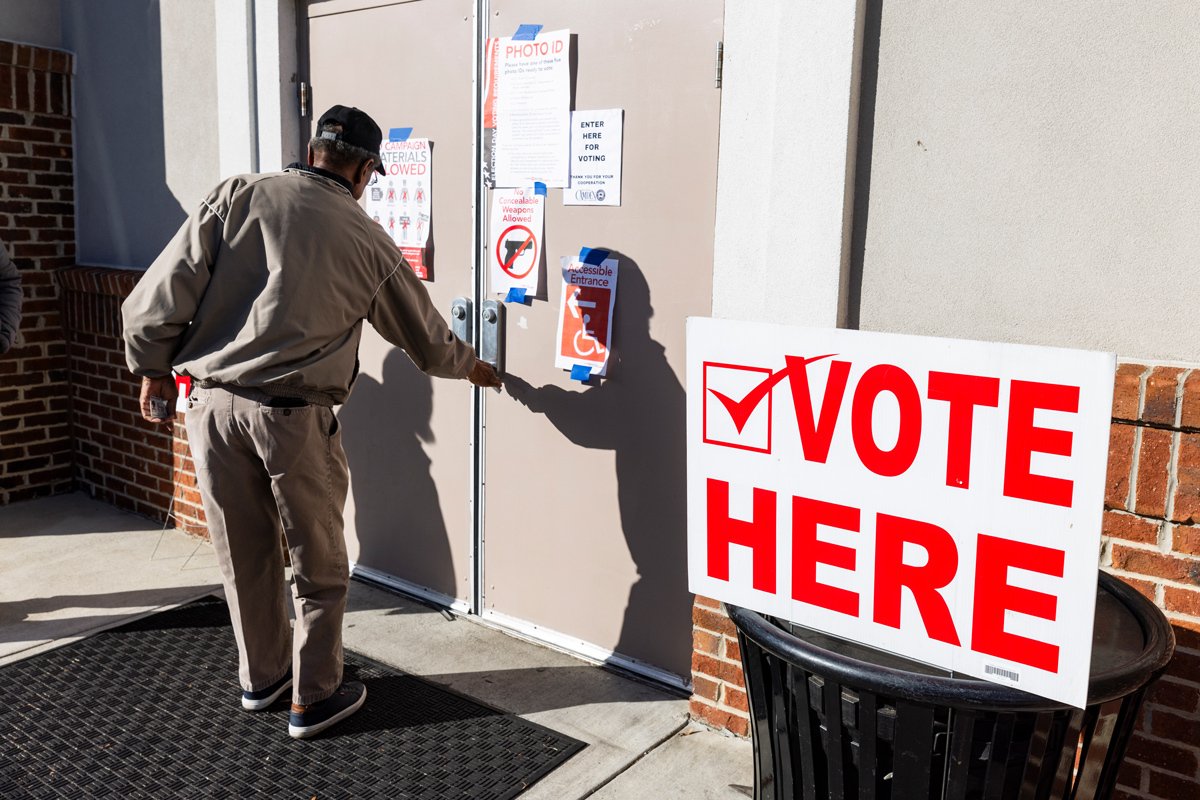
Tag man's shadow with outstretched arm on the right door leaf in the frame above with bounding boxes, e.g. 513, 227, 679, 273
505, 251, 692, 675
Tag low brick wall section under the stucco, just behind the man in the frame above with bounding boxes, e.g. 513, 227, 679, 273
59, 267, 204, 533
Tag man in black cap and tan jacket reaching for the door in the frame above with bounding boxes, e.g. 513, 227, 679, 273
121, 106, 500, 739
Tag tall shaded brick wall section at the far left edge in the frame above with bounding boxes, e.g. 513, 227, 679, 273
0, 42, 74, 505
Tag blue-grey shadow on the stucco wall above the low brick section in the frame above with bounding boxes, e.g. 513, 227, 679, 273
62, 0, 186, 267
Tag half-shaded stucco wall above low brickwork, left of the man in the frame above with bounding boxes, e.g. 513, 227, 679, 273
62, 0, 218, 267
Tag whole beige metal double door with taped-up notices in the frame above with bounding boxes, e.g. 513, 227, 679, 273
306, 0, 722, 685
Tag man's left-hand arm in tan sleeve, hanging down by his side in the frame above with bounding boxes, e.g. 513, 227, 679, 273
121, 185, 228, 422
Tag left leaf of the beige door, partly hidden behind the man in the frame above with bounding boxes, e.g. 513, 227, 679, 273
307, 0, 476, 609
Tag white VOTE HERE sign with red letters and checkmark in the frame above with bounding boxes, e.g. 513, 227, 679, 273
688, 318, 1116, 708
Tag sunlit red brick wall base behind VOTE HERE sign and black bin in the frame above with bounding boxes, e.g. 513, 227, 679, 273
691, 363, 1200, 800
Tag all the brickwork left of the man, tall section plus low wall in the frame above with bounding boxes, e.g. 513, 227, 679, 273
0, 42, 204, 533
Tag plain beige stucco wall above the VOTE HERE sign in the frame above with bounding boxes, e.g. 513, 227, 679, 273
852, 0, 1200, 361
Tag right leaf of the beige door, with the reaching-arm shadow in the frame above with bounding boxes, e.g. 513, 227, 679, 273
482, 0, 724, 682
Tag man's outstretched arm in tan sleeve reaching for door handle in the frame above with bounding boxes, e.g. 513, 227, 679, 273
367, 258, 500, 389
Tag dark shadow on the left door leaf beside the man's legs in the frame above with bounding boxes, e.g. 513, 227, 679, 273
338, 348, 457, 597
